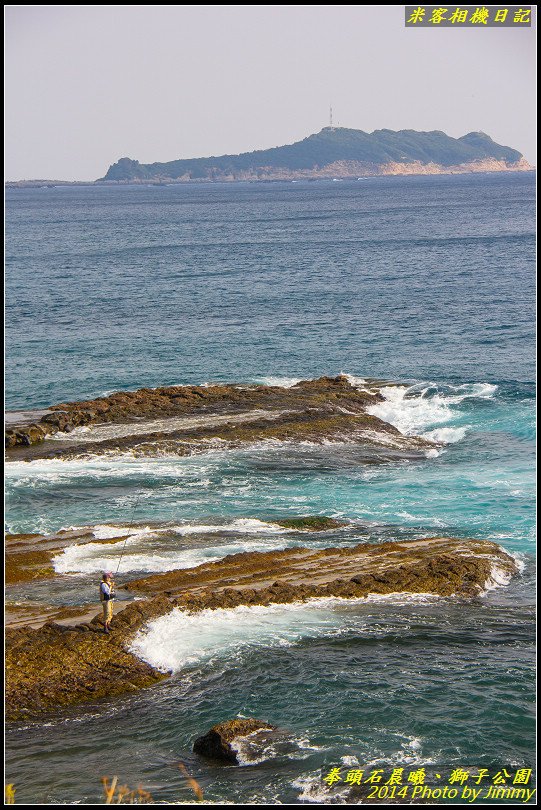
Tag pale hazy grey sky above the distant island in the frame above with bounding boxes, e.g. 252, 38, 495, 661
5, 5, 536, 180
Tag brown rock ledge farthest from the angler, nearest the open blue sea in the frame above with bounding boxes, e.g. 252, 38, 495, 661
6, 375, 433, 459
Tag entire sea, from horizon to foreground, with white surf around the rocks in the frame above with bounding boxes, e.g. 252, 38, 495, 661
5, 172, 535, 804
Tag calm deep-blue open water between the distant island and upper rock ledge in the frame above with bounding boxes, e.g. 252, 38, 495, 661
6, 173, 535, 408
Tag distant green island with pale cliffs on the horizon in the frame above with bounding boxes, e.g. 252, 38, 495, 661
6, 127, 532, 188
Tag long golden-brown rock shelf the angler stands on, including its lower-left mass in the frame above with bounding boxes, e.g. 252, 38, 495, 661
6, 537, 516, 719
